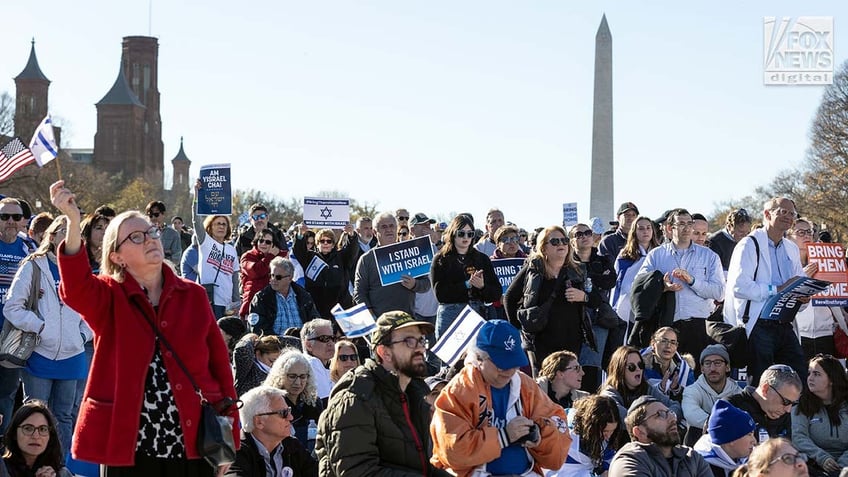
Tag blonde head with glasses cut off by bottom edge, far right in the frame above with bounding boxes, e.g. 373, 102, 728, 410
733, 437, 810, 477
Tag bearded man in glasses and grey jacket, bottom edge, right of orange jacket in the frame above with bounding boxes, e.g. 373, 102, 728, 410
608, 396, 713, 477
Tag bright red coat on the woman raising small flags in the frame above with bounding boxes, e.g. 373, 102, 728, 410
58, 243, 240, 466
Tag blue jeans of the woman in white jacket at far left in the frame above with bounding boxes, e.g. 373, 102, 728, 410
21, 371, 77, 455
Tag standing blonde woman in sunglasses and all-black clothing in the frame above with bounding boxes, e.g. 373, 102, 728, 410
504, 225, 603, 370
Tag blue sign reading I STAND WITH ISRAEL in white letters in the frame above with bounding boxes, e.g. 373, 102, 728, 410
374, 236, 433, 286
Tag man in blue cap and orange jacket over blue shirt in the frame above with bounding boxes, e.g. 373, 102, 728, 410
430, 320, 571, 477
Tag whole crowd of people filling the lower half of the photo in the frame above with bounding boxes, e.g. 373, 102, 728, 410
0, 181, 848, 477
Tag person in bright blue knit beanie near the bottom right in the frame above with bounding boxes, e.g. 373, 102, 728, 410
694, 399, 757, 477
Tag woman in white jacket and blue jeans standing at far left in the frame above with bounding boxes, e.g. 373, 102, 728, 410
3, 215, 94, 454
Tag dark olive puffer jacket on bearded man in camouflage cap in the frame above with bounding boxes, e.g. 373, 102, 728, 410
315, 359, 448, 477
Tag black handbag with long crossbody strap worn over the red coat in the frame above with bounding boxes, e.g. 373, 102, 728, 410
134, 303, 236, 469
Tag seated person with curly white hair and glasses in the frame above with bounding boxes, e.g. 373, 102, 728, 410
263, 349, 324, 452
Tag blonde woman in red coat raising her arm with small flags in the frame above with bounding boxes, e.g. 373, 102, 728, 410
50, 181, 239, 477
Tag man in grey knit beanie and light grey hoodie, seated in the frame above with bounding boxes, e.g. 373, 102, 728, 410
682, 344, 742, 443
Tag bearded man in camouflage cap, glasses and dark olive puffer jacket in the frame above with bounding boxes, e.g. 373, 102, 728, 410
315, 310, 447, 477
